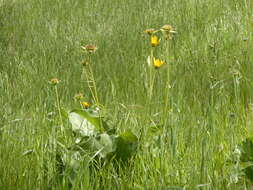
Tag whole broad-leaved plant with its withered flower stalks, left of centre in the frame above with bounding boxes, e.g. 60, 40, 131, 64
49, 39, 138, 185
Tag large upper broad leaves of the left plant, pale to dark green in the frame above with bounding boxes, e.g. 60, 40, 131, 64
69, 110, 138, 160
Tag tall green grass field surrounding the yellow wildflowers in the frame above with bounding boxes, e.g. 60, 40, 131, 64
0, 0, 253, 190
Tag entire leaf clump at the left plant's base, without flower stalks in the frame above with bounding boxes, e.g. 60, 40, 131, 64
58, 108, 138, 184
